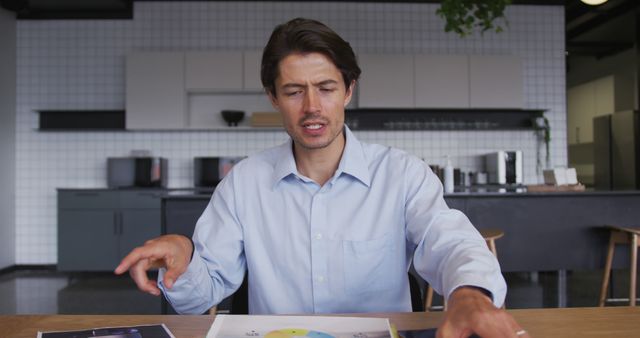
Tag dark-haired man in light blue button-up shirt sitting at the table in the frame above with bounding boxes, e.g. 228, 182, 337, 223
116, 19, 526, 337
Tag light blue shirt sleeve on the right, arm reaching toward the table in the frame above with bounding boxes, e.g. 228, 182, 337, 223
405, 160, 507, 307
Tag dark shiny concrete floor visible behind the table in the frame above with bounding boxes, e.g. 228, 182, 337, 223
0, 269, 629, 314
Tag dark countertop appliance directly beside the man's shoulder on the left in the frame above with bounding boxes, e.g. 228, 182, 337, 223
193, 157, 244, 188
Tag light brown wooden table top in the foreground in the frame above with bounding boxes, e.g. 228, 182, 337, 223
0, 307, 640, 338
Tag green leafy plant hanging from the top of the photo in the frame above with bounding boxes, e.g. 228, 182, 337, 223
436, 0, 511, 37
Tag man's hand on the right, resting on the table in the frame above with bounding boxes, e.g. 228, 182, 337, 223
436, 287, 530, 338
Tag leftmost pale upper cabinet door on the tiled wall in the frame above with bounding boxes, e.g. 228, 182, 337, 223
126, 52, 185, 129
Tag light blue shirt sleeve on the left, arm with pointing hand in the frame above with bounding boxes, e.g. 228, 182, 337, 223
158, 171, 246, 314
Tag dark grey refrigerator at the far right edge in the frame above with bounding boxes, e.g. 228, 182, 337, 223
593, 110, 640, 190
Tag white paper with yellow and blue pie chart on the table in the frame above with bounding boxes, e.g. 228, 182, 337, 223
207, 315, 393, 338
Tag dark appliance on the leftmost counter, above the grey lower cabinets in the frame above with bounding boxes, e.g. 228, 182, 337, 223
107, 157, 167, 188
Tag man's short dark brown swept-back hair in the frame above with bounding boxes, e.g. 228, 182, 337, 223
260, 18, 360, 96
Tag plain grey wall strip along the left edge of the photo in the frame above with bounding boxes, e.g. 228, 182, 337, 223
0, 8, 16, 269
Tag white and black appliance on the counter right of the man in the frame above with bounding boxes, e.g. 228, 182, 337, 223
485, 150, 523, 184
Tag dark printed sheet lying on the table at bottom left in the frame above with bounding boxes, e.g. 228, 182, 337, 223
37, 324, 175, 338
